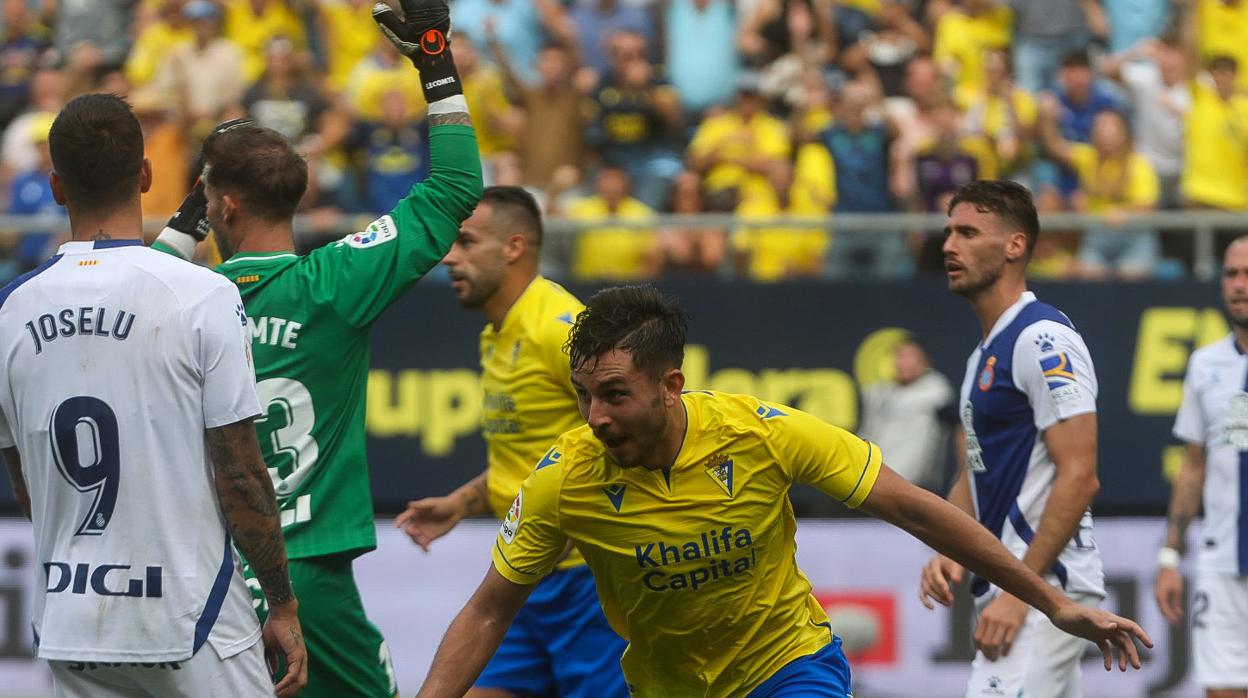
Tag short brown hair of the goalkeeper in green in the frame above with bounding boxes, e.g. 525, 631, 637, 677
203, 124, 308, 221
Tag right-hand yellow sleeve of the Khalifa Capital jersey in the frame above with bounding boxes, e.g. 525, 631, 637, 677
759, 403, 884, 508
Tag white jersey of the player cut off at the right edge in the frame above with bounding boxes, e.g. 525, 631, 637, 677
1174, 336, 1248, 576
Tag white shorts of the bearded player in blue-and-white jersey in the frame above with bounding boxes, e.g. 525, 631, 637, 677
966, 594, 1101, 698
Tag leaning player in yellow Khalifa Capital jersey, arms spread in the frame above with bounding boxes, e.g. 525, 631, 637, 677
419, 286, 1151, 698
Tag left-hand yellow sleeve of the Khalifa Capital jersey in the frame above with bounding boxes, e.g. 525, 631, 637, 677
493, 440, 568, 584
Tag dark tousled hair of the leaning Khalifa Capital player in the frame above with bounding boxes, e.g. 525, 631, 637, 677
564, 286, 689, 377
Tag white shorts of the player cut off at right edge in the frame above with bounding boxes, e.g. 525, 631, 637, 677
1189, 569, 1248, 688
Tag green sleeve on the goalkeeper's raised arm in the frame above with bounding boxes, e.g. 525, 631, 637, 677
307, 125, 482, 327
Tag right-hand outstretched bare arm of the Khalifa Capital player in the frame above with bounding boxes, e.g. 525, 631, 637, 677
861, 466, 1153, 671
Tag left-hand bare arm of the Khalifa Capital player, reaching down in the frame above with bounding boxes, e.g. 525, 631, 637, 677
417, 567, 533, 698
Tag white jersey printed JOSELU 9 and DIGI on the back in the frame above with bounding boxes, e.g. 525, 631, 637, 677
0, 241, 260, 662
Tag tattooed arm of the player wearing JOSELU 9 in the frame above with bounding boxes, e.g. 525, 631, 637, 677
205, 417, 307, 697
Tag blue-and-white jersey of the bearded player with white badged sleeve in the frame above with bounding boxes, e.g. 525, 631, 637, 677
961, 292, 1104, 598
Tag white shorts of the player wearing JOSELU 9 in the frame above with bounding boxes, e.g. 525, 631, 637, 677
47, 641, 273, 698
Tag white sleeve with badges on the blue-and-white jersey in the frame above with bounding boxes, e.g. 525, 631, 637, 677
1013, 320, 1097, 431
